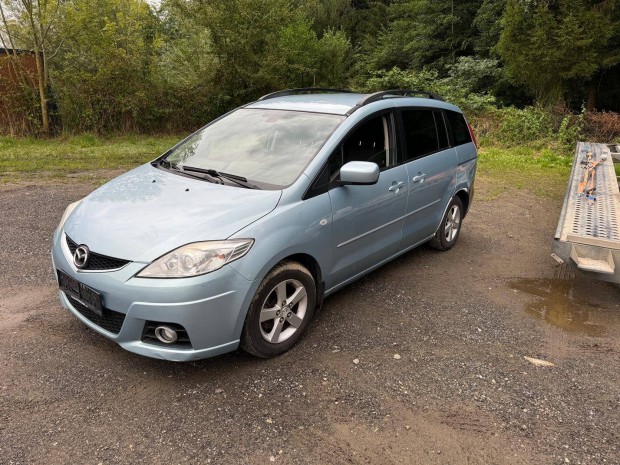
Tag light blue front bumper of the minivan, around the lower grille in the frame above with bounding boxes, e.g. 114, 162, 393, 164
52, 233, 257, 361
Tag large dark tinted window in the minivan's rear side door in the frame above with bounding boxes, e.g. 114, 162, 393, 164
401, 109, 440, 161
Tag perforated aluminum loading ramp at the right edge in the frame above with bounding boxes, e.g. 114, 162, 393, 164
553, 142, 620, 283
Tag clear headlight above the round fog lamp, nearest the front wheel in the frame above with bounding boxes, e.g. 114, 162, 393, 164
137, 239, 254, 278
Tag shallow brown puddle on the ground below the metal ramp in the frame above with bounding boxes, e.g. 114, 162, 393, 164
510, 279, 607, 337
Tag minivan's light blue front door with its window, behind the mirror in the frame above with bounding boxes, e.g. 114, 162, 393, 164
329, 113, 409, 285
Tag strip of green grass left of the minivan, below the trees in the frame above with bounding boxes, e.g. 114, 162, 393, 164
0, 134, 181, 183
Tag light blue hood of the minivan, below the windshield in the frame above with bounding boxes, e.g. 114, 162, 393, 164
64, 164, 282, 262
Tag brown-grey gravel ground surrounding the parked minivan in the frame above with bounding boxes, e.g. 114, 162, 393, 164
0, 182, 620, 465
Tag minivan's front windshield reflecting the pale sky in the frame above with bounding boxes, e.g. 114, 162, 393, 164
166, 109, 345, 188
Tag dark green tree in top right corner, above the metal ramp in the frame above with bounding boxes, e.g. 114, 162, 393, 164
498, 0, 620, 104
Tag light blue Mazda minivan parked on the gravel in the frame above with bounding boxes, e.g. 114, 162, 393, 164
52, 89, 477, 361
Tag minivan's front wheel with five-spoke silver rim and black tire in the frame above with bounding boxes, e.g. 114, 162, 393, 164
241, 261, 317, 358
